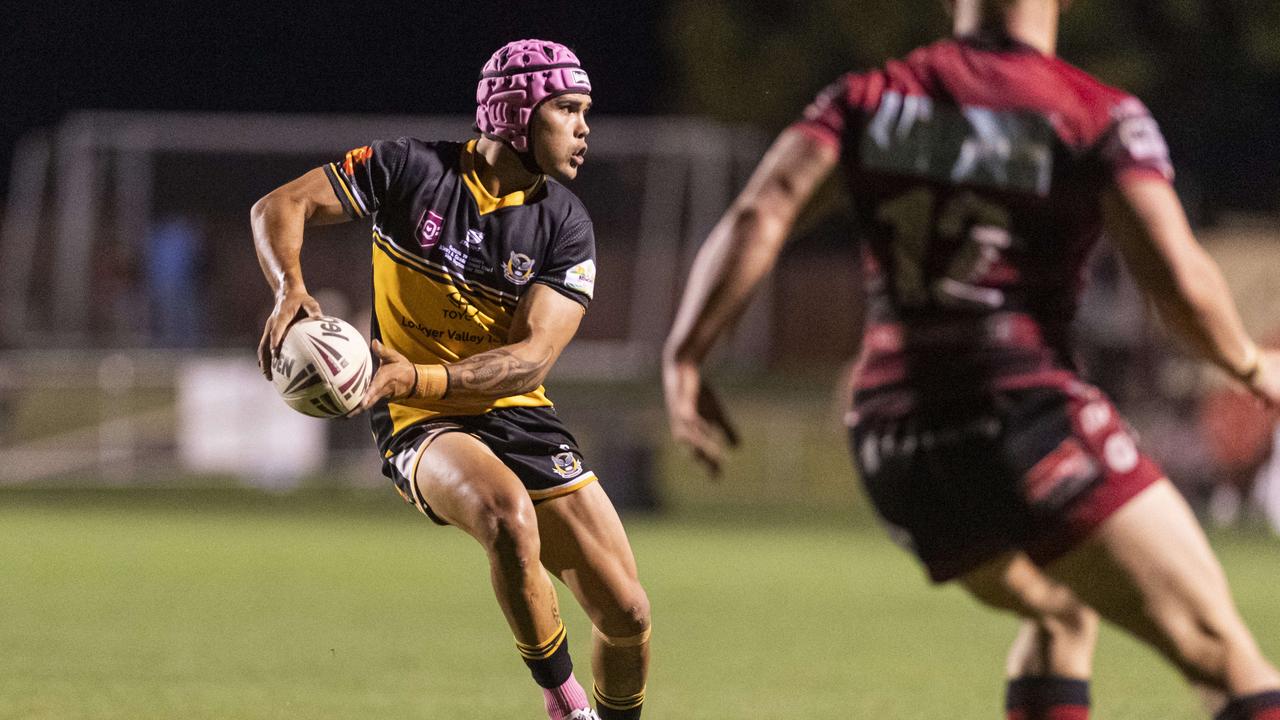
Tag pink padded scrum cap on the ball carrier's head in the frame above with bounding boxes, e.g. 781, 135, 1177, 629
476, 40, 591, 152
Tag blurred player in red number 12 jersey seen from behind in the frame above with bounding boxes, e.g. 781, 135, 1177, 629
663, 0, 1280, 720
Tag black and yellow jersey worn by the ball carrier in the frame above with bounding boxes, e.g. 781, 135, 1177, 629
325, 138, 595, 452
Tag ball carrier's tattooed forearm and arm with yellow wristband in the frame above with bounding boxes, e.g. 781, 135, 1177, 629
358, 284, 584, 413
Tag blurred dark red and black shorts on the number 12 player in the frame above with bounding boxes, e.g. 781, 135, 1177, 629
849, 382, 1164, 583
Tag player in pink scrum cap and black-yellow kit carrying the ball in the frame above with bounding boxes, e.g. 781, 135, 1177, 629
252, 40, 649, 720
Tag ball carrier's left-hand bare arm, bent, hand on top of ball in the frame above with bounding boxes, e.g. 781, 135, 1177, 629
250, 168, 348, 379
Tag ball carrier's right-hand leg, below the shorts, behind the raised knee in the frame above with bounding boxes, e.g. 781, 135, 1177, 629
538, 483, 649, 720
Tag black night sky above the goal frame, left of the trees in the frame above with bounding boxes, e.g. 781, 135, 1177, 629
0, 0, 666, 188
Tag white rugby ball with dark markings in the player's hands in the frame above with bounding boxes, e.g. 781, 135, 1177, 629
271, 316, 374, 418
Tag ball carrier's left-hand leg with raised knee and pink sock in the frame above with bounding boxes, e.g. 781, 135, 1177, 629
413, 432, 590, 719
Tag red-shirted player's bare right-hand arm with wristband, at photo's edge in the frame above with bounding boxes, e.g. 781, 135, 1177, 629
1105, 179, 1280, 405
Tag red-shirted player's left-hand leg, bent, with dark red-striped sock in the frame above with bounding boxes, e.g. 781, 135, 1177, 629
960, 552, 1098, 720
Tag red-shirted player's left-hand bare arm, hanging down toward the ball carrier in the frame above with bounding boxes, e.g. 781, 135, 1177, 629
663, 129, 838, 475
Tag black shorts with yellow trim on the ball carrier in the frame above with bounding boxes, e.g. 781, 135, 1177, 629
383, 407, 596, 525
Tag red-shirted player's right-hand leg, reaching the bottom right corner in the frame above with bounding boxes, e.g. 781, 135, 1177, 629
1047, 479, 1280, 720
